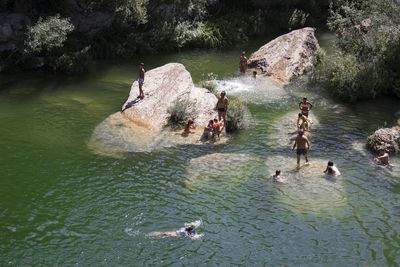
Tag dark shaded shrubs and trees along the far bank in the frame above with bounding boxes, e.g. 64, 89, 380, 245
0, 0, 329, 73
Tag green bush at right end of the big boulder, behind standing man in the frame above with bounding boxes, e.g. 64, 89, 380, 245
226, 98, 250, 132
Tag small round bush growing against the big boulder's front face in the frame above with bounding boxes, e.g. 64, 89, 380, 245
167, 99, 196, 128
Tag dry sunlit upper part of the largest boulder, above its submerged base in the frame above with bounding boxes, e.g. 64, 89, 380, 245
122, 63, 217, 130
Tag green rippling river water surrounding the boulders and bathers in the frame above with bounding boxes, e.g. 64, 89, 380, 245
0, 36, 400, 266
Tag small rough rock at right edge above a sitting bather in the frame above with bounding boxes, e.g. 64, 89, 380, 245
367, 126, 400, 153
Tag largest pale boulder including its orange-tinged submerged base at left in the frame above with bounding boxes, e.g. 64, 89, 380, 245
89, 63, 217, 155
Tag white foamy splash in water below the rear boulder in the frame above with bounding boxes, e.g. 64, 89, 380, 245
216, 77, 288, 104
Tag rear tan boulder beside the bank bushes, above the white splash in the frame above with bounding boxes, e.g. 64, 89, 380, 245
248, 28, 319, 84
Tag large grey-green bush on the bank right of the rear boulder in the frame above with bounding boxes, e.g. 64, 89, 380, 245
314, 0, 400, 101
